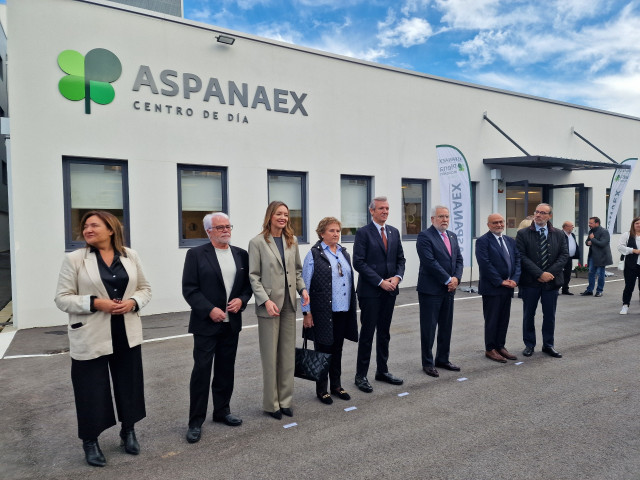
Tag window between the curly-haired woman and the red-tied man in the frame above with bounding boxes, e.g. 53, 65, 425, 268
340, 175, 371, 241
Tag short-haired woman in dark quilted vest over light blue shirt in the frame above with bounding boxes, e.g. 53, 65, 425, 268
302, 217, 358, 405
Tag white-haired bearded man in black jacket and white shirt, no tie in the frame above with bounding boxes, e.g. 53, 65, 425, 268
182, 212, 252, 443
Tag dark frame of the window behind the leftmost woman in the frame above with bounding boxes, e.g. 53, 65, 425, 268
62, 155, 131, 252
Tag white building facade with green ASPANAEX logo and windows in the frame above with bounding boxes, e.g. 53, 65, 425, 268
7, 0, 640, 328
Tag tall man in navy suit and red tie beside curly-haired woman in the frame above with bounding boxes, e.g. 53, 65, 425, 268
353, 197, 405, 393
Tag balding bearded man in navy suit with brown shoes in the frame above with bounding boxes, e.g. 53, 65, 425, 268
476, 213, 520, 363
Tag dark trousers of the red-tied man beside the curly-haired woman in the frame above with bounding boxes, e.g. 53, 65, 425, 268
356, 293, 396, 377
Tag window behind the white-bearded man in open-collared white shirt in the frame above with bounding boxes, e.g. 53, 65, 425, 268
178, 165, 228, 247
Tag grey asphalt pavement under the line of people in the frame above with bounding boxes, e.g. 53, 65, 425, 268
0, 275, 640, 480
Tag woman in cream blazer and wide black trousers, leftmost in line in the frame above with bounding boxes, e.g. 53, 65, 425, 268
55, 211, 151, 467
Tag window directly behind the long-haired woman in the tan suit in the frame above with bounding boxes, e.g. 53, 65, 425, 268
267, 170, 308, 243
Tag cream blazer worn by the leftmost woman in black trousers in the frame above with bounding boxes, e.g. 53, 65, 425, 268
55, 248, 151, 360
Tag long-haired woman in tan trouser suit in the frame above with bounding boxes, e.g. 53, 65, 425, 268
249, 201, 309, 420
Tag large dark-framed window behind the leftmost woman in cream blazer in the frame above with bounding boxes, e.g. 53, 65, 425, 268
62, 157, 129, 250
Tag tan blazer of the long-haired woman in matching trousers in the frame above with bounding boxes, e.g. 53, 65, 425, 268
249, 234, 306, 317
